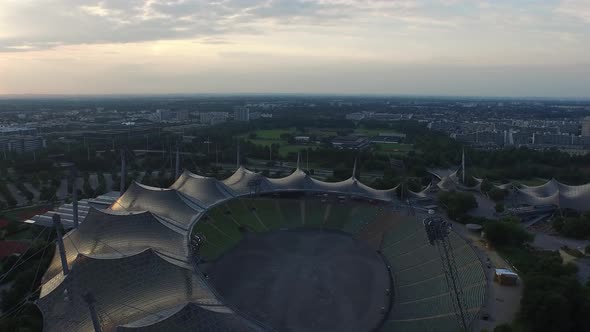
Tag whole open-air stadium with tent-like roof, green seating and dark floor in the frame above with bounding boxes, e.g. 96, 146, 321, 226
37, 162, 488, 331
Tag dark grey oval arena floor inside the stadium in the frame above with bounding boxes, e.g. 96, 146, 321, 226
206, 230, 391, 332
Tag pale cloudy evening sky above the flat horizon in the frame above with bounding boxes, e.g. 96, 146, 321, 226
0, 0, 590, 97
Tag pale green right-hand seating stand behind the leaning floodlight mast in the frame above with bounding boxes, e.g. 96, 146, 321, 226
382, 219, 486, 331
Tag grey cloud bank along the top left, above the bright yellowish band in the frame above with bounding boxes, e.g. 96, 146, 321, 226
0, 0, 468, 51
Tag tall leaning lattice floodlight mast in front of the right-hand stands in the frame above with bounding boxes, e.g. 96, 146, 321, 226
423, 215, 467, 331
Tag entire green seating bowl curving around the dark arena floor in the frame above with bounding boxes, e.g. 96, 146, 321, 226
195, 197, 486, 331
